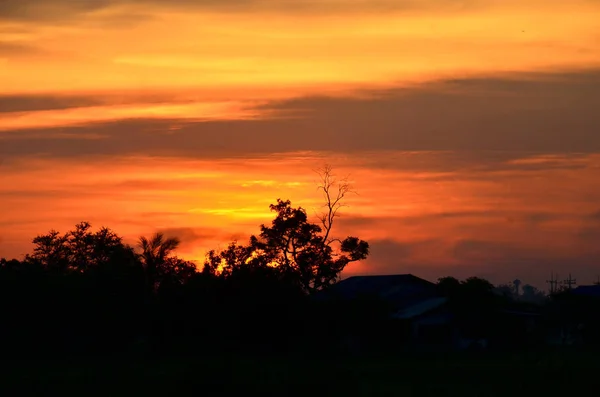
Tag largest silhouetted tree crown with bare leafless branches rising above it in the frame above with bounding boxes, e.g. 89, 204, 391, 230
203, 166, 369, 293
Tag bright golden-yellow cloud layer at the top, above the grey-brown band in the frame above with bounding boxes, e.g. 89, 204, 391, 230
0, 0, 600, 96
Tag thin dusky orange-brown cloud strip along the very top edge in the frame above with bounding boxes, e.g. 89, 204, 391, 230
0, 0, 594, 27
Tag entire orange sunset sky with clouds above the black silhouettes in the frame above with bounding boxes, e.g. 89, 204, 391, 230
0, 0, 600, 287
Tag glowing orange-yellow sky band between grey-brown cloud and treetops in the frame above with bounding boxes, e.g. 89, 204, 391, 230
0, 153, 600, 271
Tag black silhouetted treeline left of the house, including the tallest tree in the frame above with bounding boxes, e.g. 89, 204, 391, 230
0, 196, 369, 357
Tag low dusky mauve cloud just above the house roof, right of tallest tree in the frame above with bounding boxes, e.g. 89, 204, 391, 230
344, 235, 597, 289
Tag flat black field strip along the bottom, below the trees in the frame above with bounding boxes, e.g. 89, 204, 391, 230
0, 352, 600, 397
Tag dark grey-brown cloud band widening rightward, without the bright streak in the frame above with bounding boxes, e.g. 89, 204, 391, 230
0, 71, 600, 159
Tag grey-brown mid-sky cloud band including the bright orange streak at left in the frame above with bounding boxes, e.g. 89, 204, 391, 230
0, 71, 600, 157
